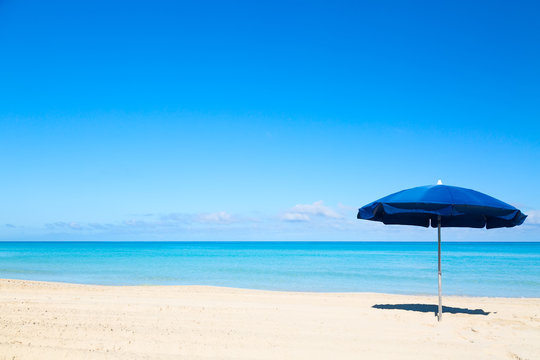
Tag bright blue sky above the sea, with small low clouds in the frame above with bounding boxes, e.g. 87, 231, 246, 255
0, 0, 540, 241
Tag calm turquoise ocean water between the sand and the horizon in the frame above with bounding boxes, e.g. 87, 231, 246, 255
0, 242, 540, 297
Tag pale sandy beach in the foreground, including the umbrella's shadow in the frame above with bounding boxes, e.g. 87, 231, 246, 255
0, 280, 540, 359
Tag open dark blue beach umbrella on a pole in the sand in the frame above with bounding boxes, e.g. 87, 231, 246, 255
357, 180, 527, 321
